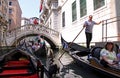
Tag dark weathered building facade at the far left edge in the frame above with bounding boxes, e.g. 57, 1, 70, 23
0, 0, 8, 46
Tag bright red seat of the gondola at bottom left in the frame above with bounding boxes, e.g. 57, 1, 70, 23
0, 60, 38, 78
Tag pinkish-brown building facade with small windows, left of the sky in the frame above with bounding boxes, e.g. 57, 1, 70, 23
8, 0, 22, 30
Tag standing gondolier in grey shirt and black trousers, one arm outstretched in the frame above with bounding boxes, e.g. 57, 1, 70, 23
83, 15, 101, 48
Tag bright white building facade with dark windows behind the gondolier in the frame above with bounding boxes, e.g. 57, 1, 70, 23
40, 0, 120, 43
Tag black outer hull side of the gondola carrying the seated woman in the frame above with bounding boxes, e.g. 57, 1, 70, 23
71, 55, 120, 78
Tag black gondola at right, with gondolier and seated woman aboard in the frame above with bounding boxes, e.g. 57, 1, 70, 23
61, 38, 120, 78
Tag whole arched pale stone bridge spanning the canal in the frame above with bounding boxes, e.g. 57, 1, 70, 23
5, 24, 61, 48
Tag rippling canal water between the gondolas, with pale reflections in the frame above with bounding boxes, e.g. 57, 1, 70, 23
40, 50, 109, 78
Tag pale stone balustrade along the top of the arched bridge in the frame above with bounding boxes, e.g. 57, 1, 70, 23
6, 24, 59, 38
